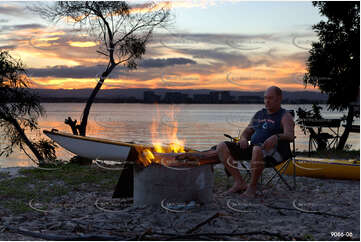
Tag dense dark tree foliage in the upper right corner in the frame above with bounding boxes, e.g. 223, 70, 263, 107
304, 1, 360, 110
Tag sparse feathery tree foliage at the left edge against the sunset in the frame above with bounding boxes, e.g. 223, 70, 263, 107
0, 51, 55, 164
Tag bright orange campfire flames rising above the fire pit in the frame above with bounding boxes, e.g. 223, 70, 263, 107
137, 106, 185, 166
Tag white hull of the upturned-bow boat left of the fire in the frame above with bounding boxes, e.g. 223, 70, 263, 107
44, 131, 133, 161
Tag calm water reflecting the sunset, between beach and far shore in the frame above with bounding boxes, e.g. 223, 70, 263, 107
0, 103, 360, 167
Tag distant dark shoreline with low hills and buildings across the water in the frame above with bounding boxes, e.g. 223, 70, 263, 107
31, 88, 328, 104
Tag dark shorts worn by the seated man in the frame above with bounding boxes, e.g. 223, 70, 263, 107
224, 141, 285, 167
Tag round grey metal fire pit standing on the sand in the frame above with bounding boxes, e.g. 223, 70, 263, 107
134, 164, 213, 206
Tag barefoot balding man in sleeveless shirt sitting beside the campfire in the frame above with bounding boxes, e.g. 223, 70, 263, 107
177, 86, 295, 197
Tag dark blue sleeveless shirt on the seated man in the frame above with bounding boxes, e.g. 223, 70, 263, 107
251, 108, 286, 145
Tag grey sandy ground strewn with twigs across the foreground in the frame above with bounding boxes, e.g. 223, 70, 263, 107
0, 164, 360, 240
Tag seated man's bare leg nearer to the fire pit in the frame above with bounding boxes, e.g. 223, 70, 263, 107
216, 142, 247, 193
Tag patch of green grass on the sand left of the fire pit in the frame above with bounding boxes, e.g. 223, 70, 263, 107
0, 164, 120, 214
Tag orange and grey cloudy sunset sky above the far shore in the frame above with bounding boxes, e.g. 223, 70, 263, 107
0, 0, 322, 91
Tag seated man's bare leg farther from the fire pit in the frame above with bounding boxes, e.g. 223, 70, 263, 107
242, 146, 264, 197
